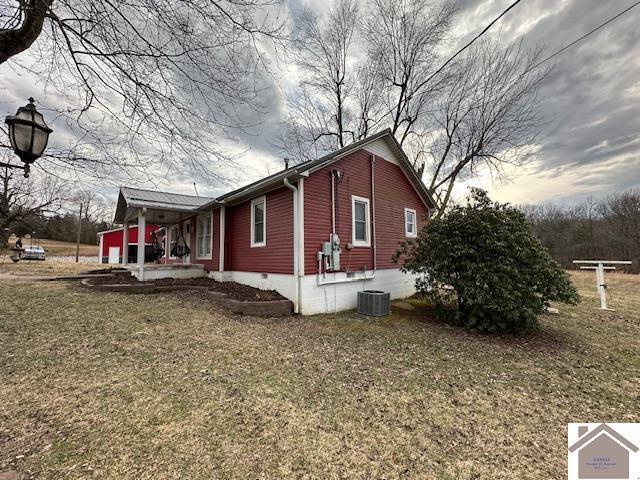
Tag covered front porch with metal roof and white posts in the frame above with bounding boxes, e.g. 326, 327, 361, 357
114, 187, 211, 281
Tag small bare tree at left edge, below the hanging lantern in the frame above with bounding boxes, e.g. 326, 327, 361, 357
0, 168, 68, 248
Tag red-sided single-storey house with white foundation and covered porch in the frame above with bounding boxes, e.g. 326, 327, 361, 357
114, 130, 434, 314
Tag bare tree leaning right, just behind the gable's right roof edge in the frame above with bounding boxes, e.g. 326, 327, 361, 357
428, 41, 548, 215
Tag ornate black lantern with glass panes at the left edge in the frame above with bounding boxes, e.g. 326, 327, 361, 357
0, 98, 53, 178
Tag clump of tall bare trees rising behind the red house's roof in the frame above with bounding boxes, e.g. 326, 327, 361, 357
280, 0, 547, 215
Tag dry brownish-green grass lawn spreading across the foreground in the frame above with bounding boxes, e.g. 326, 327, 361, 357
0, 272, 640, 480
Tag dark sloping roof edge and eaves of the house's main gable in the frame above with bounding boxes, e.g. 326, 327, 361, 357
205, 128, 436, 209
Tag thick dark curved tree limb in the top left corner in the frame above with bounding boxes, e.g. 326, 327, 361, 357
0, 0, 53, 64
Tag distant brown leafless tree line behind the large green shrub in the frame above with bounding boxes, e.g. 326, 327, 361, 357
520, 189, 640, 273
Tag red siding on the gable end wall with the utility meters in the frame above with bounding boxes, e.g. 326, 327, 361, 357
304, 150, 427, 274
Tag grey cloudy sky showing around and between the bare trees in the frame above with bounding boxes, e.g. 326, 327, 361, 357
0, 0, 640, 208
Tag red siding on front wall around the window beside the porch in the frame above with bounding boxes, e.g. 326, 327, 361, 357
224, 187, 293, 274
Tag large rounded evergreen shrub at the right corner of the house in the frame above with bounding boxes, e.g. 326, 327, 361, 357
398, 189, 580, 332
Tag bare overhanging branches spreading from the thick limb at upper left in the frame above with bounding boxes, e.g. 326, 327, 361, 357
0, 0, 284, 181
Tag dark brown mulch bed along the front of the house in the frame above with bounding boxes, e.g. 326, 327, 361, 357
82, 275, 286, 302
